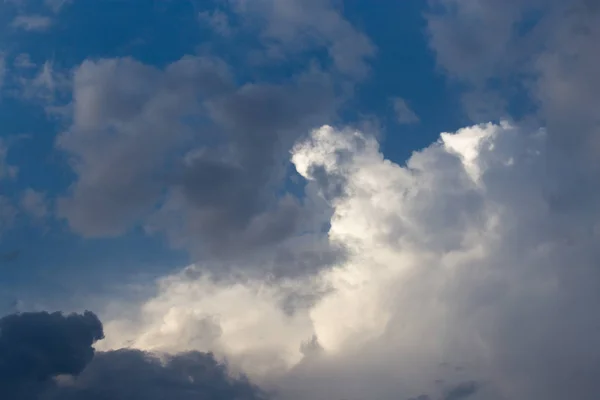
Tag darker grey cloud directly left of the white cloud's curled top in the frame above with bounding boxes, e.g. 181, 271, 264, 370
151, 68, 334, 256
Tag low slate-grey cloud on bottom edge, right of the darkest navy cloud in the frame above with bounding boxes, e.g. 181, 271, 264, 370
45, 350, 266, 400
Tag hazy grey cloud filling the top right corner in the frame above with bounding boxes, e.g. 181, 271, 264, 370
428, 0, 600, 128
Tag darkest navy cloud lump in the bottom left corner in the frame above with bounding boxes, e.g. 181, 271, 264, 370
0, 312, 104, 399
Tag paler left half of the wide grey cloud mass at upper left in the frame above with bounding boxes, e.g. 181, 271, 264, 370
57, 57, 230, 236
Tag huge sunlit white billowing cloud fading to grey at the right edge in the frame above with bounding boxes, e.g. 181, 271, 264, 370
98, 123, 600, 400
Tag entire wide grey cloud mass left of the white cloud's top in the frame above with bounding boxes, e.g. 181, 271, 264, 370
57, 53, 335, 264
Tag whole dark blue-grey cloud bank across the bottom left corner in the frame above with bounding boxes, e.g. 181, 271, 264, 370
0, 312, 266, 400
